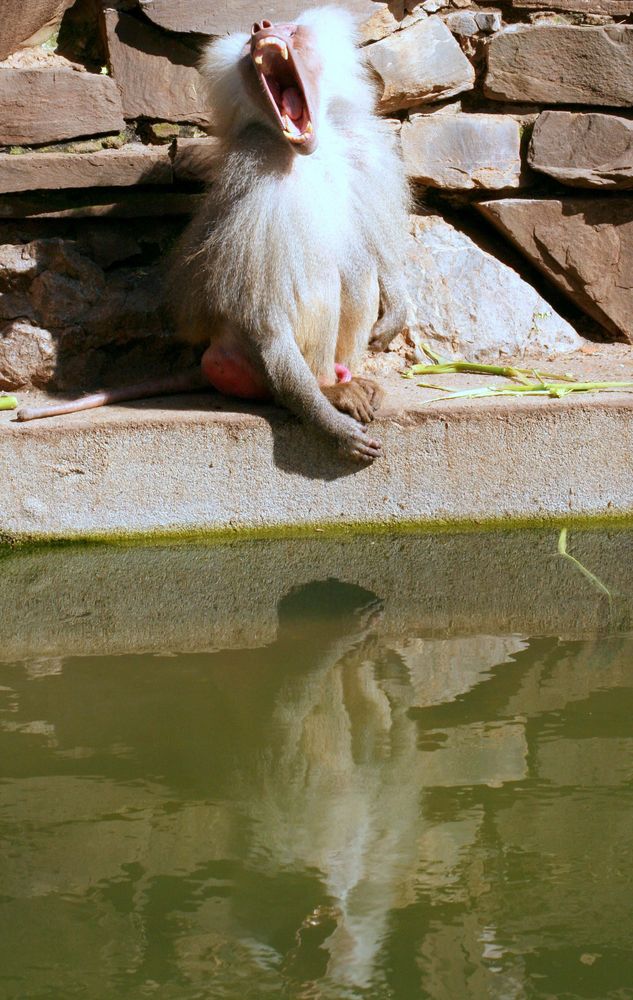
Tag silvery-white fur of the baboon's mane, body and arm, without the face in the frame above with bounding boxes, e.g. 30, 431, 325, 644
173, 8, 409, 460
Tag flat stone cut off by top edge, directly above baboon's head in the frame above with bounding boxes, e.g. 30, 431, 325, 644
140, 0, 388, 35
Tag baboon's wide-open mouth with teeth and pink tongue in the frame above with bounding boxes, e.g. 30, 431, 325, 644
251, 34, 315, 152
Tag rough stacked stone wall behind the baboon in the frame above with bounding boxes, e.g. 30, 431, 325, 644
0, 0, 633, 388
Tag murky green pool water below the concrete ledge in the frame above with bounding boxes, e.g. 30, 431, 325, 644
0, 532, 633, 1000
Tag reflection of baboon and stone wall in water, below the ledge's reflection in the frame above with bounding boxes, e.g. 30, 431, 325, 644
0, 580, 633, 1000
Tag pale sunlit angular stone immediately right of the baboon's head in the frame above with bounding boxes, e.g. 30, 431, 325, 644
364, 16, 475, 111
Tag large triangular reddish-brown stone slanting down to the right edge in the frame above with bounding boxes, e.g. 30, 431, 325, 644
477, 198, 633, 341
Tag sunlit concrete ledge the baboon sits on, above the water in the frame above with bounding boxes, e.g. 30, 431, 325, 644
0, 363, 633, 541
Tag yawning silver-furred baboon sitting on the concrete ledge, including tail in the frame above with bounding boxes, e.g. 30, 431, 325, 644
18, 7, 409, 461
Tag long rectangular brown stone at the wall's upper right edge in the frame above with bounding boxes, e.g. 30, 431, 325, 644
484, 24, 633, 107
